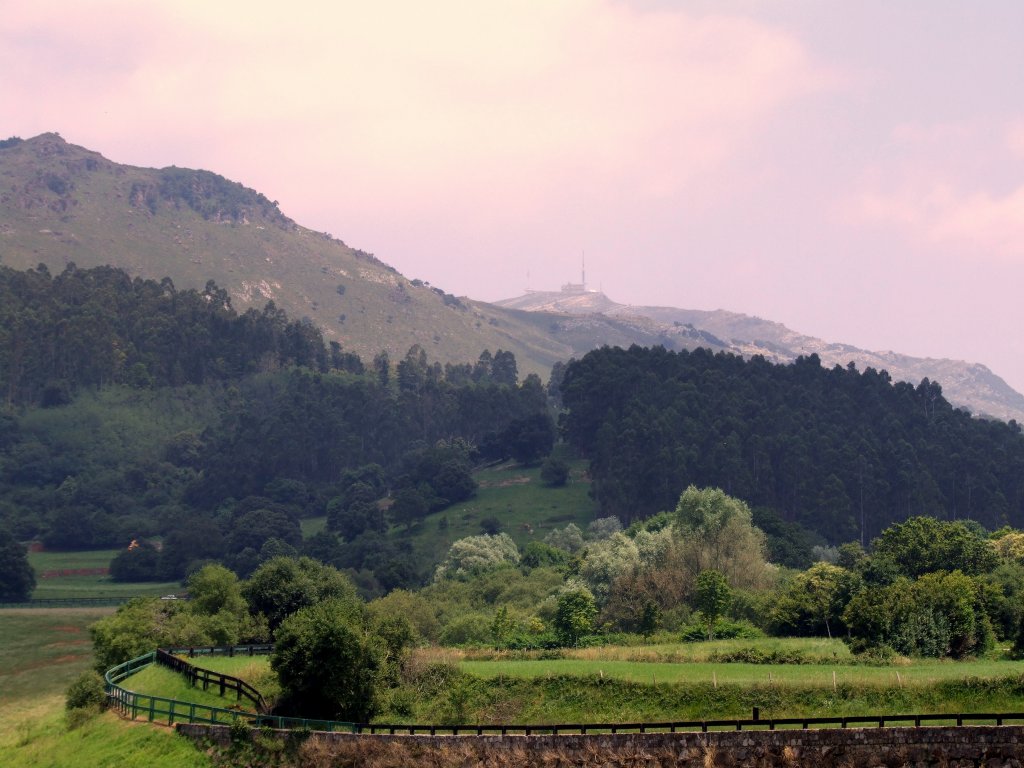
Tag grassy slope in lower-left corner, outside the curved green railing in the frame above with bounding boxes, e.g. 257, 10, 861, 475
0, 608, 211, 768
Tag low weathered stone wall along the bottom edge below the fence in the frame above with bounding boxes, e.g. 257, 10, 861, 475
178, 724, 1024, 768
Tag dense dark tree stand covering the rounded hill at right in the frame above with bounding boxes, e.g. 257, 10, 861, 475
560, 346, 1024, 546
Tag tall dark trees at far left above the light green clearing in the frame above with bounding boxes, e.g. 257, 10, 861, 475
0, 265, 328, 407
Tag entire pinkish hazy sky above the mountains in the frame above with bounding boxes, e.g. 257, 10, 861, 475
6, 0, 1024, 391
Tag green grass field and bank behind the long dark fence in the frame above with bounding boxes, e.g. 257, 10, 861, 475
190, 639, 1024, 724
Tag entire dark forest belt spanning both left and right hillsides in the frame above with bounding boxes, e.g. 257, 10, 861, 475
6, 265, 1024, 594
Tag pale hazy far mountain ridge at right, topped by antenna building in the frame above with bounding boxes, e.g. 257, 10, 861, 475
496, 292, 1024, 423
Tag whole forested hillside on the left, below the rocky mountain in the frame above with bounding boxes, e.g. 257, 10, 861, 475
0, 266, 555, 589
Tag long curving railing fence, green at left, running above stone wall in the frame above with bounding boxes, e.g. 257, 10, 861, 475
104, 645, 1024, 736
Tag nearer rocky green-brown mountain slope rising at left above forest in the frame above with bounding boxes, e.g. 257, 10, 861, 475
0, 133, 573, 376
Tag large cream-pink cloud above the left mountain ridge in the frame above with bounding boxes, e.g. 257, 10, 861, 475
0, 0, 825, 222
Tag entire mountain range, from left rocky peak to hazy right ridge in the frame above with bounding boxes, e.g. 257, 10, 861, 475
0, 133, 1024, 422
